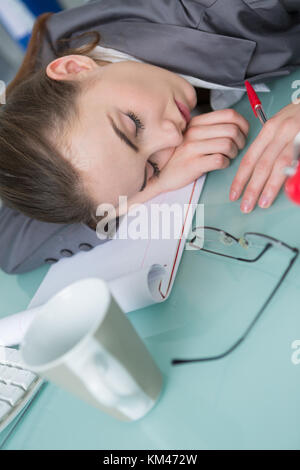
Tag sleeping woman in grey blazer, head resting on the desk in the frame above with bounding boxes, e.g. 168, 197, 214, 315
0, 0, 300, 273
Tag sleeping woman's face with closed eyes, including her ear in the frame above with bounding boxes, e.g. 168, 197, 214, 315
47, 55, 197, 206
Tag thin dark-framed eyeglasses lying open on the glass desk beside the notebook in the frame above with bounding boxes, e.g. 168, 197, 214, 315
171, 226, 299, 365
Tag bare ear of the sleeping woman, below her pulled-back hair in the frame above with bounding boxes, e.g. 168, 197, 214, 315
46, 55, 99, 80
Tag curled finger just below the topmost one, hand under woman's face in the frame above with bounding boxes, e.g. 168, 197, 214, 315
187, 137, 239, 162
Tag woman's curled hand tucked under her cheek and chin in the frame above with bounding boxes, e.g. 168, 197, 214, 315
152, 109, 249, 192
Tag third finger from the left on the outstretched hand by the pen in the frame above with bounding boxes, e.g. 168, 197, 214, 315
258, 144, 293, 209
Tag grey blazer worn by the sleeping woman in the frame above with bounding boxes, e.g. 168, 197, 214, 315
0, 0, 300, 273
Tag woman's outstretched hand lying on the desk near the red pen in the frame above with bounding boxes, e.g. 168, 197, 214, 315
229, 104, 300, 212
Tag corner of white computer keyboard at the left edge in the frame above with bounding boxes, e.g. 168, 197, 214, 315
0, 346, 44, 433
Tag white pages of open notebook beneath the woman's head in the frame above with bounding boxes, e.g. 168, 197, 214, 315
28, 175, 205, 310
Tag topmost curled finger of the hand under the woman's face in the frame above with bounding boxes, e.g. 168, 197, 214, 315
188, 109, 249, 136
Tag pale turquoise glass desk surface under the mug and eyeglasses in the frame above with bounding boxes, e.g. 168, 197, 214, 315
0, 71, 300, 450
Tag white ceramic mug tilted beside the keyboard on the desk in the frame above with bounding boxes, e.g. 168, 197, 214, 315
20, 278, 162, 421
